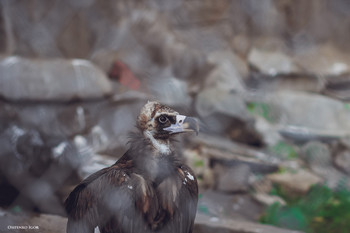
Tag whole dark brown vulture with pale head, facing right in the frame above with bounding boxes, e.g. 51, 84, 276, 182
65, 101, 199, 233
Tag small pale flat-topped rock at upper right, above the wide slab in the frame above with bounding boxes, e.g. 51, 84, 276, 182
248, 48, 299, 76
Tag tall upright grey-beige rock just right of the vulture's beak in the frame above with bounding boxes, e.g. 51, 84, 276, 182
195, 51, 251, 136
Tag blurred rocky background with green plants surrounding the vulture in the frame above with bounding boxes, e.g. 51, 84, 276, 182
0, 0, 350, 233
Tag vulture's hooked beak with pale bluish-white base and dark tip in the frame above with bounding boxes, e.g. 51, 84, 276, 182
164, 115, 199, 135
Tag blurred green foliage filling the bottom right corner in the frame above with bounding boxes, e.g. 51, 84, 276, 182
260, 186, 350, 233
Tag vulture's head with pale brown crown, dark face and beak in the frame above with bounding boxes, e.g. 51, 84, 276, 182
137, 101, 199, 153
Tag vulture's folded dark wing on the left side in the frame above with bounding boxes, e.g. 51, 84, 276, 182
65, 161, 133, 233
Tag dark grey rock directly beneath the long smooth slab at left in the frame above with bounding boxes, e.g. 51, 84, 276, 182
0, 101, 98, 137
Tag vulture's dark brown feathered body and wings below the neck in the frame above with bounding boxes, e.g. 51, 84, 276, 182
65, 152, 198, 233
